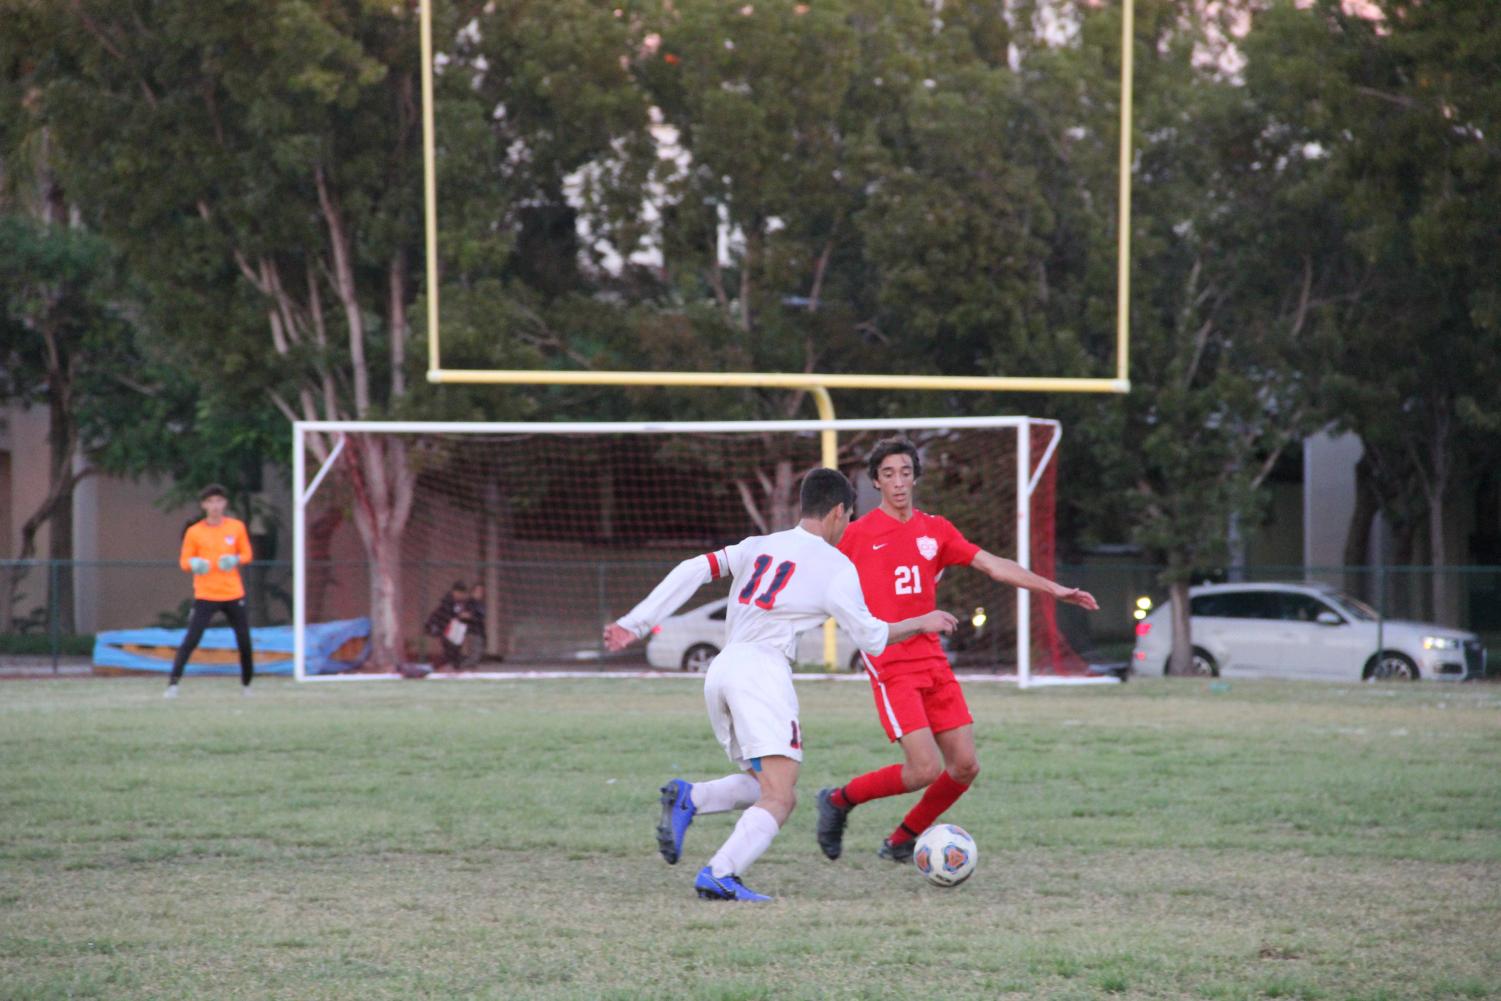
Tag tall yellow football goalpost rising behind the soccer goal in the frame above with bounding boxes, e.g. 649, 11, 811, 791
419, 0, 1135, 681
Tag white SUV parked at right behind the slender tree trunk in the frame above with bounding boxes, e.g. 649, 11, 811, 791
1132, 584, 1486, 681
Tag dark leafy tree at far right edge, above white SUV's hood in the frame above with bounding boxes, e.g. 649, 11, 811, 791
1247, 0, 1501, 615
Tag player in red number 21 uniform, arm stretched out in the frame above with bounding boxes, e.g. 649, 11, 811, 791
818, 438, 1099, 861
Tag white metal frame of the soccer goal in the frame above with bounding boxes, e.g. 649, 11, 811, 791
291, 417, 1092, 687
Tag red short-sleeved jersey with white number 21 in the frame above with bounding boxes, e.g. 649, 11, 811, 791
839, 507, 980, 669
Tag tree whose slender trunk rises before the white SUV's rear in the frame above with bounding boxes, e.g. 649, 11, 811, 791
1044, 3, 1349, 674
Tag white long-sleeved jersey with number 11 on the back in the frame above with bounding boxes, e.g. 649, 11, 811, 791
618, 527, 890, 660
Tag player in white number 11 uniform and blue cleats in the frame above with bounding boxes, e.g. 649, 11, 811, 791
605, 470, 955, 900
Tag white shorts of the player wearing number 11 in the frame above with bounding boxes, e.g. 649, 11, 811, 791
704, 644, 803, 768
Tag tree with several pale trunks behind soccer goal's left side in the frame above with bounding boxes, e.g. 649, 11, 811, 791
13, 0, 639, 666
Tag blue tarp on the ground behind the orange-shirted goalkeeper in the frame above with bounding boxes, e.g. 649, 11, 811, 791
93, 618, 371, 677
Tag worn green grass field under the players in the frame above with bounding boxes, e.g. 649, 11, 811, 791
0, 678, 1501, 1001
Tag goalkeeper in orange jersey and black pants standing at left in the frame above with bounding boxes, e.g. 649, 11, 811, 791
167, 483, 255, 699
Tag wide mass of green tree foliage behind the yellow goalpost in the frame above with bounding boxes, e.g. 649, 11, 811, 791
0, 0, 1501, 603
